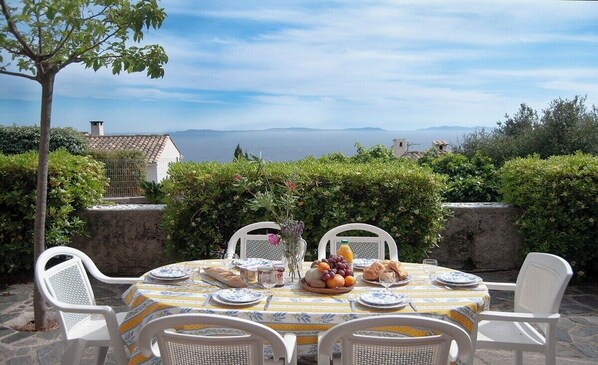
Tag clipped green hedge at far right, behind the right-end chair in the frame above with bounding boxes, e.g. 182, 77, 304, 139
501, 153, 598, 277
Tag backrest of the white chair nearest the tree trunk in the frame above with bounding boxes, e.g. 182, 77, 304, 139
35, 246, 97, 339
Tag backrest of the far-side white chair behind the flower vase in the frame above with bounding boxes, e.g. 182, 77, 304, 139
227, 222, 283, 260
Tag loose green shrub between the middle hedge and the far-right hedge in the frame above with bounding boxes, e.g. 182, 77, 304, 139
418, 149, 500, 203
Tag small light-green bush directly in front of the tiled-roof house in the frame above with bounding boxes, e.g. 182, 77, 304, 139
90, 150, 147, 197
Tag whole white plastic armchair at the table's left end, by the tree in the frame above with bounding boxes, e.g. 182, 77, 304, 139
35, 246, 141, 365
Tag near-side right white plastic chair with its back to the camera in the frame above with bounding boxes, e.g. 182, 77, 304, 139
318, 315, 472, 365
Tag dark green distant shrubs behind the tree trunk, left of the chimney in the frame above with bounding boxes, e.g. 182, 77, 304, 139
0, 125, 87, 155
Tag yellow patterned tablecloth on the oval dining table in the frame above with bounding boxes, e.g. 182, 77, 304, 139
120, 260, 490, 364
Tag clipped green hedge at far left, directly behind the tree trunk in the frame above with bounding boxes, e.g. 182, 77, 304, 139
0, 150, 106, 275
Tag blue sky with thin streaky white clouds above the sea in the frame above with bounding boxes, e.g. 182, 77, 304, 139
0, 0, 598, 134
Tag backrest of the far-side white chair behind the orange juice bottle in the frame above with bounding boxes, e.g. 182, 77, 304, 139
318, 223, 399, 261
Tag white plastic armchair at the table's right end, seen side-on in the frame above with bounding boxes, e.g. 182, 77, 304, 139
472, 252, 573, 365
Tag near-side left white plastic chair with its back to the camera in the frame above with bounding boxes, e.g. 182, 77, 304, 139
138, 313, 297, 365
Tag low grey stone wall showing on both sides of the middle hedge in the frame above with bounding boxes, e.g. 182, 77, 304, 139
73, 203, 522, 276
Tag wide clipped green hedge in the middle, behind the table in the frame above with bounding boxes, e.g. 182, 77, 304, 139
164, 159, 448, 261
